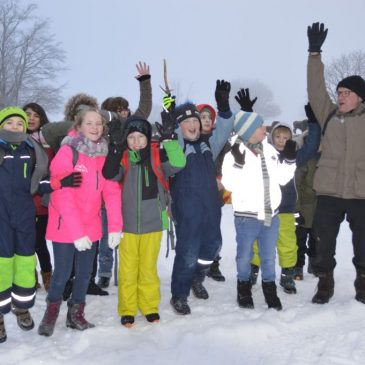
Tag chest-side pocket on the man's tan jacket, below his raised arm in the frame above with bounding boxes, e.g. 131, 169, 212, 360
313, 158, 338, 194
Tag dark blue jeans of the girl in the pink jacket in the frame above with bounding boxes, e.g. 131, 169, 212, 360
47, 242, 97, 304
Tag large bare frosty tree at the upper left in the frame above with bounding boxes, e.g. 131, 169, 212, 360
0, 0, 65, 112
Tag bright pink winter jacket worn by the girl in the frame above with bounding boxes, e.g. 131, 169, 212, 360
46, 145, 122, 243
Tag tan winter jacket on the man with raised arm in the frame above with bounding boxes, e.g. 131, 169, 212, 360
307, 55, 365, 199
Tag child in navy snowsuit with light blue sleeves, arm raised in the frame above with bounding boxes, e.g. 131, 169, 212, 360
170, 80, 233, 315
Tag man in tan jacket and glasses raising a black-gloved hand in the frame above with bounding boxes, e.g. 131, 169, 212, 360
307, 23, 365, 304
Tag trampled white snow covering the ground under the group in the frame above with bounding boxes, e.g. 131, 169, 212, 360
0, 206, 365, 365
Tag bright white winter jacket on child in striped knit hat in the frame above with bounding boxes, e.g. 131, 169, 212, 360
222, 140, 296, 220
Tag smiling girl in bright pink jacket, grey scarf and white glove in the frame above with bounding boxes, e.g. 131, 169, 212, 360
38, 107, 122, 336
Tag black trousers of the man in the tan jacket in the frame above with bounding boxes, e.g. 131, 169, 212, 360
313, 195, 365, 273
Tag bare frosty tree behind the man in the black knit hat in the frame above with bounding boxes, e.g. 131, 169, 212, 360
325, 50, 365, 101
